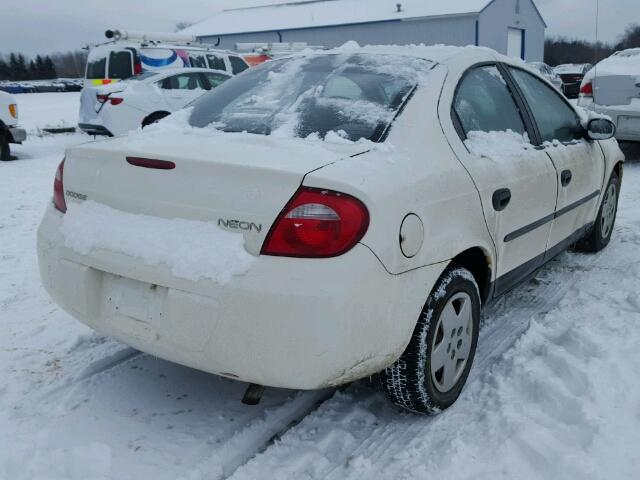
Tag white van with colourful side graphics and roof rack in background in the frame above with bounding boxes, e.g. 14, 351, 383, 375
84, 30, 249, 87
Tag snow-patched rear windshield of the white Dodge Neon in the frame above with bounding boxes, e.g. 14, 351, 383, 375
189, 54, 434, 142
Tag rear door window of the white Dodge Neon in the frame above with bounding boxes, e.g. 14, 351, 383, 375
453, 65, 525, 135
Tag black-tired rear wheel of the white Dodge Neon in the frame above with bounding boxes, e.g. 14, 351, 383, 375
380, 267, 480, 415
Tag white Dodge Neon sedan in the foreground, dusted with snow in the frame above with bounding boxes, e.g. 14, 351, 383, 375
38, 46, 624, 413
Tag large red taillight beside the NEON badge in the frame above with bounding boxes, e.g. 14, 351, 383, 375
261, 187, 369, 258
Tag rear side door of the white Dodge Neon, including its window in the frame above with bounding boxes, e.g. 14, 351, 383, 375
451, 65, 557, 294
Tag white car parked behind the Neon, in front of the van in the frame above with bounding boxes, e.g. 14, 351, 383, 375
78, 68, 231, 136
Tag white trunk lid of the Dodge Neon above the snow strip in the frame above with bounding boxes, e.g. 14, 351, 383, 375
64, 129, 368, 255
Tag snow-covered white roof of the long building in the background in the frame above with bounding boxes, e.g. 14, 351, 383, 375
181, 0, 492, 37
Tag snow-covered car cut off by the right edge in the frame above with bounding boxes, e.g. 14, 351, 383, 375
578, 48, 640, 142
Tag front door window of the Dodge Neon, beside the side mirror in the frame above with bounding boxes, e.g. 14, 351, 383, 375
511, 68, 583, 142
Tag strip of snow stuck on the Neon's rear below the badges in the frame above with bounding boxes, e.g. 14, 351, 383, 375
62, 201, 253, 285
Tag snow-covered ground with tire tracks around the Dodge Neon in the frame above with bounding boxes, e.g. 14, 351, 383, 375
0, 94, 640, 480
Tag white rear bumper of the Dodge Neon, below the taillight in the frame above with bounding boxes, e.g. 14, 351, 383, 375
38, 207, 445, 389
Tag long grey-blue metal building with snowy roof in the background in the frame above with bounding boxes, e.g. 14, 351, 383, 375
183, 0, 546, 61
